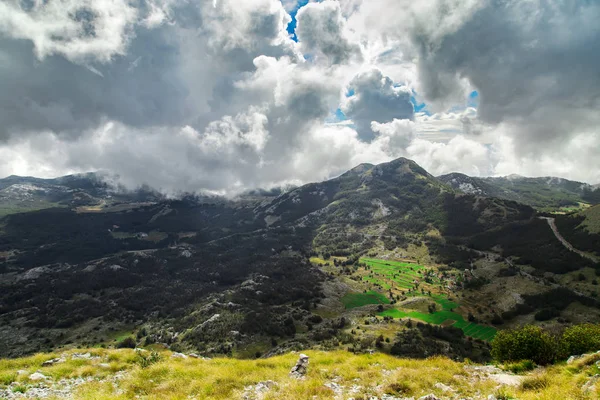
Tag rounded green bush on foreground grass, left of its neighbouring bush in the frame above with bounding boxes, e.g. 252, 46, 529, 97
492, 325, 558, 365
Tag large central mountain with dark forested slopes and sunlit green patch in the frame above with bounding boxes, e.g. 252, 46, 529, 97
0, 158, 600, 360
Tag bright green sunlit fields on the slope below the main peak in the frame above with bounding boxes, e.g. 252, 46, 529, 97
356, 258, 497, 341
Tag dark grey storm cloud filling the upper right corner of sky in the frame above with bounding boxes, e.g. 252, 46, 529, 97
413, 0, 600, 145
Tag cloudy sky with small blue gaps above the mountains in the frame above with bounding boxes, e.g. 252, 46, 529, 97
0, 0, 600, 195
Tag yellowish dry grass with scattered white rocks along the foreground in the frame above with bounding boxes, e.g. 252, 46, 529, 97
0, 349, 600, 400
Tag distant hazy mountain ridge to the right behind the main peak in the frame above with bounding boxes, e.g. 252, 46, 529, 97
438, 172, 600, 210
